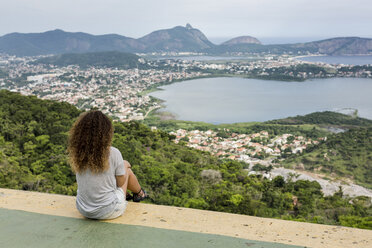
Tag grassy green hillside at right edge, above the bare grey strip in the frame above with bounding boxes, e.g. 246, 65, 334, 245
282, 126, 372, 189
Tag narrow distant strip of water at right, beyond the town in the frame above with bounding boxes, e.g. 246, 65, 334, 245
298, 55, 372, 65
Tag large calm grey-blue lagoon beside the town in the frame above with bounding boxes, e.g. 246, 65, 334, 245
150, 78, 372, 123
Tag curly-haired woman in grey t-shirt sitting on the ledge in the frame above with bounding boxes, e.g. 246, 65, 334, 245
68, 111, 147, 219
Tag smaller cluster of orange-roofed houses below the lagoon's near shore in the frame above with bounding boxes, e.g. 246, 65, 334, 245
170, 129, 327, 168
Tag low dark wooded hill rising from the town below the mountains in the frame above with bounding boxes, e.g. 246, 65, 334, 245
35, 51, 144, 69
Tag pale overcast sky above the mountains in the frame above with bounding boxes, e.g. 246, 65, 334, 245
0, 0, 372, 41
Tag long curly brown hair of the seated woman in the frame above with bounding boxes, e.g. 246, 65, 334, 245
67, 110, 114, 173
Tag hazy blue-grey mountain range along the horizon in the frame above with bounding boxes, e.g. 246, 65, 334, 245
0, 24, 372, 56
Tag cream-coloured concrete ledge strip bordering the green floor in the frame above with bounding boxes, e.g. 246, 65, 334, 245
0, 188, 372, 247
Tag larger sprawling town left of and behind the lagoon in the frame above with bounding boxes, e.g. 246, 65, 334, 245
0, 54, 372, 121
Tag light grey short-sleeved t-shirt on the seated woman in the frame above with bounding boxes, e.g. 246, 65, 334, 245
76, 147, 125, 219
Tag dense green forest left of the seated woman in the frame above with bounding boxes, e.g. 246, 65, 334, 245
0, 90, 80, 195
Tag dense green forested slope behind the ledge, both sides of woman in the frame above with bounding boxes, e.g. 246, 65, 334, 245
0, 90, 372, 229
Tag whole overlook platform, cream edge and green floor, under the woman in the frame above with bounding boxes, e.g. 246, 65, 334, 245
0, 188, 372, 248
